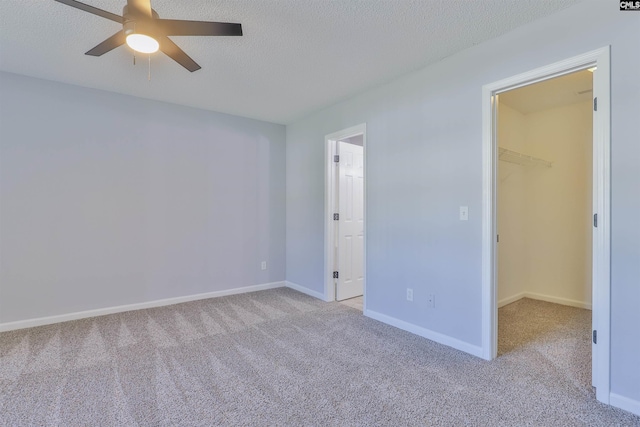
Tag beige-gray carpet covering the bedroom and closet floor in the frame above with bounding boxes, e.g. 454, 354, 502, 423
0, 288, 640, 426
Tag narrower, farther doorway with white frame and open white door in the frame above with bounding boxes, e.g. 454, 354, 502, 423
324, 124, 366, 311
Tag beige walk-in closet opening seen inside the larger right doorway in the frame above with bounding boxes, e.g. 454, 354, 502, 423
495, 68, 597, 384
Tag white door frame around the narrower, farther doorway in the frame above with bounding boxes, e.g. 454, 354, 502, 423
324, 123, 367, 304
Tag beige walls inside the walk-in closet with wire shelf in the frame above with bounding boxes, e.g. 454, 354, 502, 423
498, 101, 593, 308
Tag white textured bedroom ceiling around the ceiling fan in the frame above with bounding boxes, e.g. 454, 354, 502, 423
0, 0, 580, 124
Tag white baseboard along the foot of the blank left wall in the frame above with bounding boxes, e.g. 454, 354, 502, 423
0, 282, 285, 332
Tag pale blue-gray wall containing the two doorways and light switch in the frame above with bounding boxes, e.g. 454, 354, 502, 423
287, 1, 640, 401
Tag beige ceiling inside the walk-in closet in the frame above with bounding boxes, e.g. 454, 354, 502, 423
500, 70, 593, 114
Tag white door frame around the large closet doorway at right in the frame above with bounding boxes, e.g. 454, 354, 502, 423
482, 46, 611, 403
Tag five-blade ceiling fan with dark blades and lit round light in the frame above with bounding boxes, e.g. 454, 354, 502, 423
55, 0, 242, 72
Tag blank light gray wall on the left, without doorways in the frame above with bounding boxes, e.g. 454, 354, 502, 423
0, 73, 285, 323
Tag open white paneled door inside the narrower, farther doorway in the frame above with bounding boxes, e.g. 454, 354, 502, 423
336, 142, 364, 301
